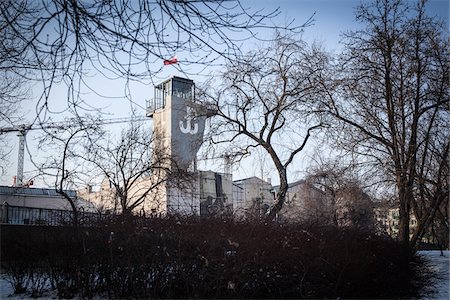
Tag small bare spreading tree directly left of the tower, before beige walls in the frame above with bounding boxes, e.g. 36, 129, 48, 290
83, 121, 189, 216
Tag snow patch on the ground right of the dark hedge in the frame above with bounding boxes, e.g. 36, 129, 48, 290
419, 250, 450, 300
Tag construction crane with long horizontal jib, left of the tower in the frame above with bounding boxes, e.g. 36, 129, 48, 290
0, 116, 147, 187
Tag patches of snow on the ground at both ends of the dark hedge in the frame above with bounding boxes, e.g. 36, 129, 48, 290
0, 250, 450, 300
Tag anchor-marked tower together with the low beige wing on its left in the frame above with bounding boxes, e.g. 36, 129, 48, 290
80, 76, 211, 216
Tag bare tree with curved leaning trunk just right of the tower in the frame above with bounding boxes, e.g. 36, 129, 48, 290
201, 35, 327, 219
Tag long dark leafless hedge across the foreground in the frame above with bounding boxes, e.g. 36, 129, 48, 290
1, 218, 424, 298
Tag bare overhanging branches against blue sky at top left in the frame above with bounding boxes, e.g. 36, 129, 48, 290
0, 0, 312, 121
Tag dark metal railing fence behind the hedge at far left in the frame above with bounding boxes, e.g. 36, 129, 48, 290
0, 203, 102, 226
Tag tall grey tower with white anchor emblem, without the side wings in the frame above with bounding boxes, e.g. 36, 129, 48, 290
147, 76, 206, 215
